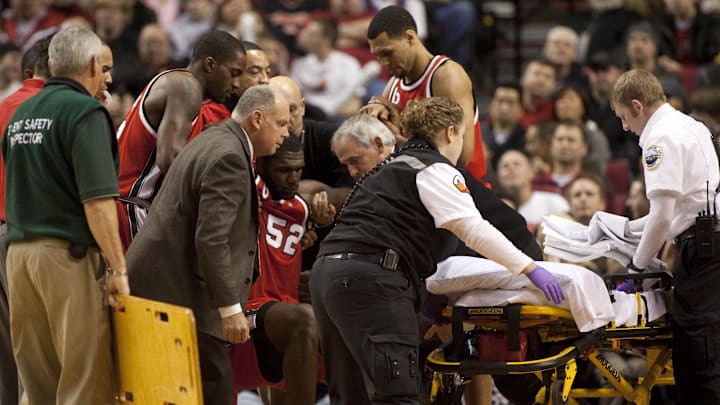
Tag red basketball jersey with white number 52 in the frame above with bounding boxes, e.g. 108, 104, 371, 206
246, 176, 310, 310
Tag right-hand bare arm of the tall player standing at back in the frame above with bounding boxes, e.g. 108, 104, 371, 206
431, 60, 475, 164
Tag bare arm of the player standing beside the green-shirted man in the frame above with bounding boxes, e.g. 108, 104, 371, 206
145, 72, 203, 173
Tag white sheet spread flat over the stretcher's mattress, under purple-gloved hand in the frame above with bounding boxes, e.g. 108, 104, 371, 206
425, 256, 666, 332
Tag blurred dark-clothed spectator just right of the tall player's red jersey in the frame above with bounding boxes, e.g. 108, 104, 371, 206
480, 83, 525, 169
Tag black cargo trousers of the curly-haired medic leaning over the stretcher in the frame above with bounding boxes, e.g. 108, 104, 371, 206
310, 258, 420, 405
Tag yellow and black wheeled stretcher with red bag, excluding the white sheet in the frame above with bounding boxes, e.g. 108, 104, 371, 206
426, 258, 674, 405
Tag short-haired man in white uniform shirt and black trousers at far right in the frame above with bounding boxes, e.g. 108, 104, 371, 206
612, 70, 720, 405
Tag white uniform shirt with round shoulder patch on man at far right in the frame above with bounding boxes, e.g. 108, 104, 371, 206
639, 103, 720, 240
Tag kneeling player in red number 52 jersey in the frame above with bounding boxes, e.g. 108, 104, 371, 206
229, 136, 332, 405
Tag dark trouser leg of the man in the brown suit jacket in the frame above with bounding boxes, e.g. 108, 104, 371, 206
198, 332, 236, 405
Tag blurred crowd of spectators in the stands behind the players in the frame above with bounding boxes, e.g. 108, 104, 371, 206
0, 0, 720, 400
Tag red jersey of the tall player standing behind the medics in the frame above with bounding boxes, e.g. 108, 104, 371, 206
388, 55, 487, 180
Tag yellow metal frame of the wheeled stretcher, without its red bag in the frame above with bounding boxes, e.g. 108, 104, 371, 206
426, 273, 675, 405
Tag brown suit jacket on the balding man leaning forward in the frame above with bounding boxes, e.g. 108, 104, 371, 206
127, 119, 258, 339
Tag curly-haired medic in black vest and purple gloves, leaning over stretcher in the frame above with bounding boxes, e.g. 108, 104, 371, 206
310, 97, 564, 405
